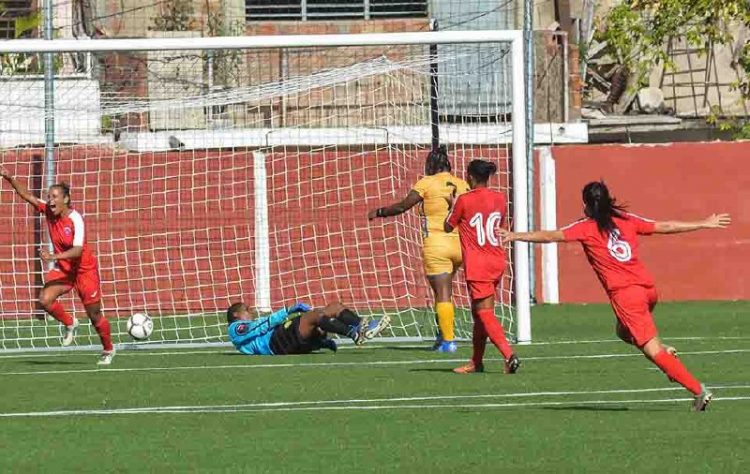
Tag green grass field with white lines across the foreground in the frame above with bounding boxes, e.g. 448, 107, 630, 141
0, 302, 750, 473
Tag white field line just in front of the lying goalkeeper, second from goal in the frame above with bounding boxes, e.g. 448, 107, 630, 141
0, 349, 750, 376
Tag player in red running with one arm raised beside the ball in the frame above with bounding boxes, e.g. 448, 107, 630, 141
0, 165, 115, 365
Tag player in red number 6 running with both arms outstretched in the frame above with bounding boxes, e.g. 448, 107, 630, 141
499, 182, 731, 411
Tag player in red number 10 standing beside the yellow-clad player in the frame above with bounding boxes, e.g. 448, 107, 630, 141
444, 160, 520, 374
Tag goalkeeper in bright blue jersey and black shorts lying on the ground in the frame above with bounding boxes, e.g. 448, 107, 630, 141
227, 302, 390, 355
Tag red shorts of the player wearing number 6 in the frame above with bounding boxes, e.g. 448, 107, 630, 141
609, 285, 658, 347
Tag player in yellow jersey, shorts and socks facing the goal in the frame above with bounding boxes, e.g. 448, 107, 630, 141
367, 145, 469, 352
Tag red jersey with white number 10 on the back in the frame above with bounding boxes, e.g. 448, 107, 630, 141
446, 188, 508, 281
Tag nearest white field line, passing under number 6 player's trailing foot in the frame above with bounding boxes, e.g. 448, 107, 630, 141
0, 396, 750, 418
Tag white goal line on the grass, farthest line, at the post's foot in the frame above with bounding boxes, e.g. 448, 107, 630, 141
0, 336, 750, 359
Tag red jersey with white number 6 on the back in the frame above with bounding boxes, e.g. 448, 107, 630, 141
562, 213, 655, 292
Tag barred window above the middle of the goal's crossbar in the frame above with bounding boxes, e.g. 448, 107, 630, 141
245, 0, 427, 21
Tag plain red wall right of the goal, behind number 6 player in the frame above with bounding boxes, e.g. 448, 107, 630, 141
552, 142, 750, 302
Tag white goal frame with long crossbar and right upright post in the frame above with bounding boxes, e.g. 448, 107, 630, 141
0, 30, 531, 343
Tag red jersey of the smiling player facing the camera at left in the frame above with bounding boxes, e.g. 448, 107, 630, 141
37, 201, 97, 273
